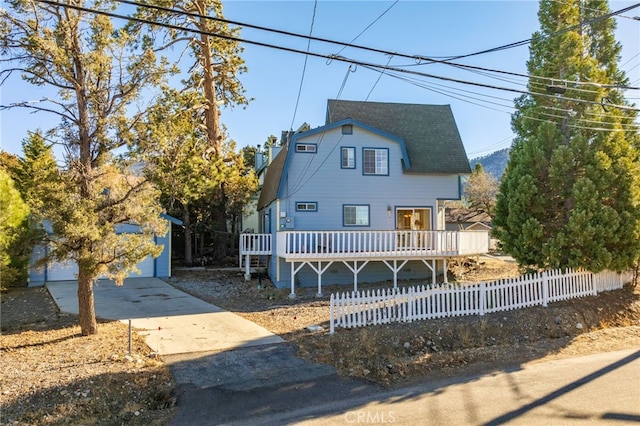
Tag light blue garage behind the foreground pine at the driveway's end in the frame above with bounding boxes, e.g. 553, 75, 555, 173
29, 214, 182, 286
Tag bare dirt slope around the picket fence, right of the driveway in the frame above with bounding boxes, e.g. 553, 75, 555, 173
170, 258, 640, 385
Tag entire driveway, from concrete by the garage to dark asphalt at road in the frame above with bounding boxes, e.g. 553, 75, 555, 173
47, 278, 350, 426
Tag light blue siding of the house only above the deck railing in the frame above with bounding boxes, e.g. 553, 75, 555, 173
280, 126, 460, 230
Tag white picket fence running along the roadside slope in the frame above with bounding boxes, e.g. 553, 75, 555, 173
330, 269, 633, 334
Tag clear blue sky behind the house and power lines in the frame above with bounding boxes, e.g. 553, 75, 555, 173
0, 0, 640, 158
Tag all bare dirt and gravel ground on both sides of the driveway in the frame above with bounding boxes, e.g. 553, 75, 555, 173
0, 260, 640, 425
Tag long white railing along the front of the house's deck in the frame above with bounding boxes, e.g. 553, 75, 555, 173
262, 231, 489, 259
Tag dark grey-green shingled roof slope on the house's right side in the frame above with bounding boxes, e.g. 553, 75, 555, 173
326, 99, 471, 174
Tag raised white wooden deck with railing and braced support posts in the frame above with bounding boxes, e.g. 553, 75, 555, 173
240, 231, 489, 297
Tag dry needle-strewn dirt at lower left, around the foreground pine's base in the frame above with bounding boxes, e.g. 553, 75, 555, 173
0, 287, 175, 425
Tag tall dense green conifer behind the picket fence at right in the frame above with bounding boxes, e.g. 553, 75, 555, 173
493, 0, 640, 272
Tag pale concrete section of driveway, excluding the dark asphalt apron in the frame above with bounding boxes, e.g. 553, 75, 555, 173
47, 278, 282, 355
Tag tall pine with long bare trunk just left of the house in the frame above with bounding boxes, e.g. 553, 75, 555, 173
132, 0, 249, 253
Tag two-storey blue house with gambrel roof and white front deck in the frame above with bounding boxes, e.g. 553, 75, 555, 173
240, 100, 488, 296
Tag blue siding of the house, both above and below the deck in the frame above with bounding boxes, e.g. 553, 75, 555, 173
265, 122, 460, 288
